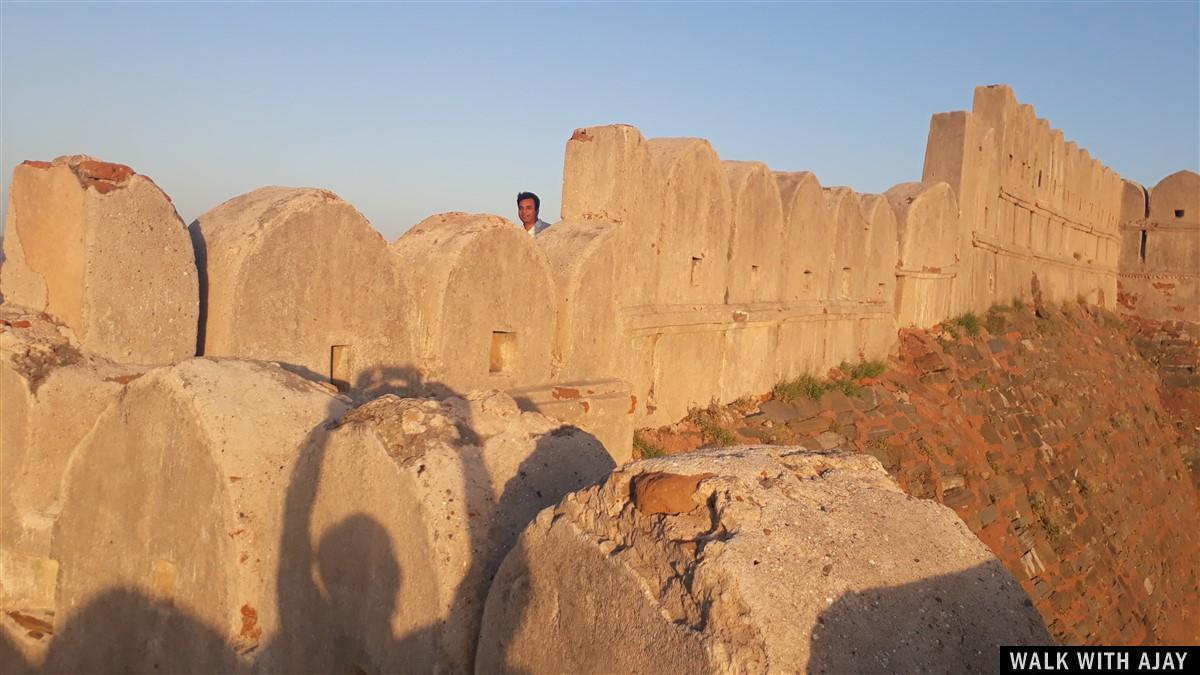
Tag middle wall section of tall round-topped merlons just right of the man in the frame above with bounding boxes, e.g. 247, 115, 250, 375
561, 126, 895, 425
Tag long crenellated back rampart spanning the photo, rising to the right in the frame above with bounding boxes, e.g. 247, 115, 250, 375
4, 85, 1200, 447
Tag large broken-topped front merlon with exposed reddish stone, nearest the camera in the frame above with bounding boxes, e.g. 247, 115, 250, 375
476, 447, 1050, 673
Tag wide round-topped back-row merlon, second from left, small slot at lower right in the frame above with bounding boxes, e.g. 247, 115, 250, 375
191, 187, 419, 395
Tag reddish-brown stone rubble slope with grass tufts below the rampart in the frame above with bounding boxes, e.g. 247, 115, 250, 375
638, 301, 1200, 645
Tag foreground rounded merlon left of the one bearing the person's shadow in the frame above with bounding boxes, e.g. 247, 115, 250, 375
44, 359, 348, 673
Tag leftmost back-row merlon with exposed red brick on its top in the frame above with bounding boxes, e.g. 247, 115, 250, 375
0, 155, 199, 365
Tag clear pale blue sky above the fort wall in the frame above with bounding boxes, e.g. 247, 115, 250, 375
0, 0, 1200, 239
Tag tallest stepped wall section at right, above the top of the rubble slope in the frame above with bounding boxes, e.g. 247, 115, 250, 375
923, 85, 1123, 313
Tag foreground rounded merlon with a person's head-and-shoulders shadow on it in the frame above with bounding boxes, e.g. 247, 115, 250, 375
274, 392, 613, 673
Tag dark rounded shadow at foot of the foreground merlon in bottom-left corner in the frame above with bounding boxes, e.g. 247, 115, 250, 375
40, 589, 241, 675
